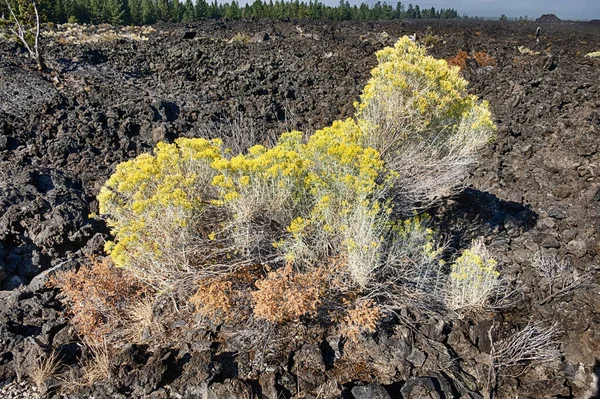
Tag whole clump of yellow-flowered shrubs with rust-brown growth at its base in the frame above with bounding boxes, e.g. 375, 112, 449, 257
98, 38, 502, 332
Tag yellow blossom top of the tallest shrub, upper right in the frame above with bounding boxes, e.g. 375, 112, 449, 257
355, 36, 494, 135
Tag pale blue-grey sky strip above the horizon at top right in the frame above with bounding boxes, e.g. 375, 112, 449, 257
342, 0, 600, 20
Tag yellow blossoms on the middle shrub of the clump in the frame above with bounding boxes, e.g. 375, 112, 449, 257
212, 119, 384, 260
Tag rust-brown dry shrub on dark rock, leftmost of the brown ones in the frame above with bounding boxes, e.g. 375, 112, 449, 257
48, 257, 148, 343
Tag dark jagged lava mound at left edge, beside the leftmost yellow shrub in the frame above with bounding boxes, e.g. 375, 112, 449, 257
0, 167, 94, 289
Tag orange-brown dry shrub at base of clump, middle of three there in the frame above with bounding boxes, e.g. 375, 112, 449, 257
252, 263, 326, 324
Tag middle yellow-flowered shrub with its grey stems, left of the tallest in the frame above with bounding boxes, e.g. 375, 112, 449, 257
213, 119, 383, 278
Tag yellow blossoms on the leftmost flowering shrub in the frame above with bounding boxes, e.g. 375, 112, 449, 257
98, 138, 222, 266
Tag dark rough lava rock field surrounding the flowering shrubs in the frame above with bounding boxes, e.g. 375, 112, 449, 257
0, 21, 600, 399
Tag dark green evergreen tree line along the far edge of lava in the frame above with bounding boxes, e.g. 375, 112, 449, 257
0, 0, 459, 25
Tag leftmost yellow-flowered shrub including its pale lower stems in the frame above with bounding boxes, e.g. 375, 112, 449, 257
98, 139, 221, 285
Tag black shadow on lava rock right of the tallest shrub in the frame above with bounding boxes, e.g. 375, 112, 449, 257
431, 188, 538, 249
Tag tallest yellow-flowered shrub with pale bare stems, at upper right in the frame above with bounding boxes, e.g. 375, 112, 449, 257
355, 37, 495, 211
